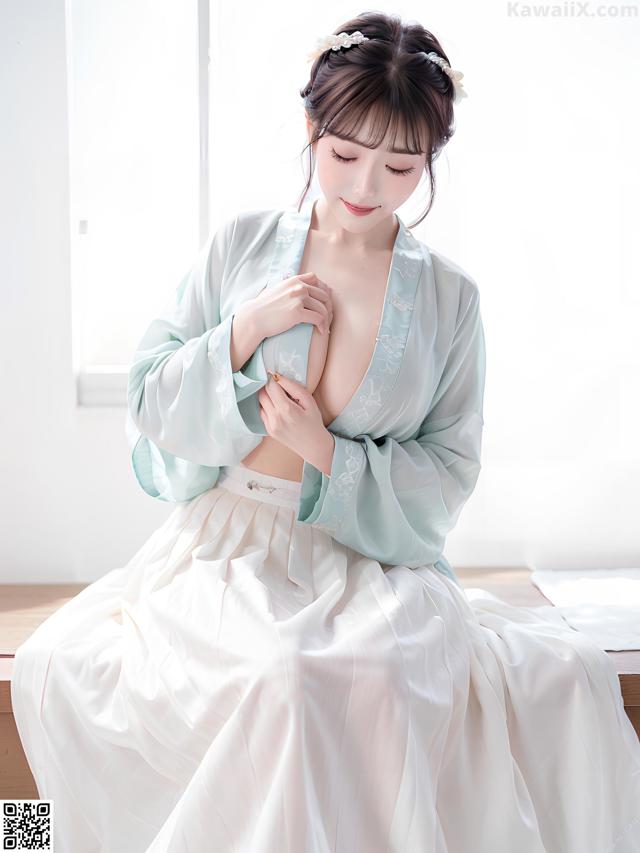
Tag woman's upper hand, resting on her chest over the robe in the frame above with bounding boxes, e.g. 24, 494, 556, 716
241, 272, 333, 341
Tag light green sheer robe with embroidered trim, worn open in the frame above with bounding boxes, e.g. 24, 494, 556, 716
126, 202, 485, 581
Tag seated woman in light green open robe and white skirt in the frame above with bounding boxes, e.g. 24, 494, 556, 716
12, 13, 640, 853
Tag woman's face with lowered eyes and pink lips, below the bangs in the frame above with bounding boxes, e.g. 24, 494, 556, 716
307, 112, 426, 231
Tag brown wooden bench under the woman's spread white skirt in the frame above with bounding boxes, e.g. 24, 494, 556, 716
0, 569, 640, 799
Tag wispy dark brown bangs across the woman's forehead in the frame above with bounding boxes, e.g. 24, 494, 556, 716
318, 93, 428, 154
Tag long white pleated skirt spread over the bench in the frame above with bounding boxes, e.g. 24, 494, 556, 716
11, 465, 640, 853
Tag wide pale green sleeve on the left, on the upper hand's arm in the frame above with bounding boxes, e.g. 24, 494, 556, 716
125, 218, 268, 501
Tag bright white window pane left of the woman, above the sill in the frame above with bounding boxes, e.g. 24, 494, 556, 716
67, 0, 200, 405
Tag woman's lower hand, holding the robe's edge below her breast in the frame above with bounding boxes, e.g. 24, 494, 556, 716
258, 374, 334, 474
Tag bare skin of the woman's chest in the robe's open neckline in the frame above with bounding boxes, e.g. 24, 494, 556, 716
300, 232, 392, 425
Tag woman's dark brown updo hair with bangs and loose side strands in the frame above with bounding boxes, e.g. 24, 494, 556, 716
298, 12, 454, 228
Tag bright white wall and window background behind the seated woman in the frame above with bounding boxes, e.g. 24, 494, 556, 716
0, 0, 640, 583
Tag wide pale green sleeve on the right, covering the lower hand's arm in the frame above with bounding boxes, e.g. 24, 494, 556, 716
298, 284, 485, 568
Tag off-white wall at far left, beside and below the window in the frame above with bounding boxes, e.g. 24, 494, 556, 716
0, 0, 162, 583
